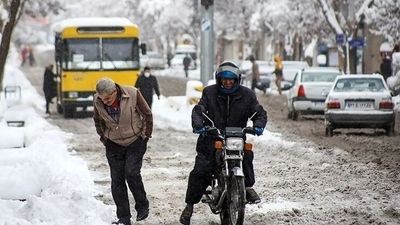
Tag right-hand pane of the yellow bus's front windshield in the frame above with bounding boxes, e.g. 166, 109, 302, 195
102, 38, 139, 70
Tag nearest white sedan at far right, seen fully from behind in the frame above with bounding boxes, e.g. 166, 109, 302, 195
325, 74, 395, 136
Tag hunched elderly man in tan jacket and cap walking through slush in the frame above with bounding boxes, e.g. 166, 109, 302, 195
93, 78, 153, 225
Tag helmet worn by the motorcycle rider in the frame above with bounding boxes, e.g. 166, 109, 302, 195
215, 61, 242, 94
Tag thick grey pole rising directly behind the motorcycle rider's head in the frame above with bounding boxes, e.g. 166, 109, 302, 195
200, 0, 214, 85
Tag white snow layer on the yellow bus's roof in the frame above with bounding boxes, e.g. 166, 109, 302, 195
52, 17, 136, 32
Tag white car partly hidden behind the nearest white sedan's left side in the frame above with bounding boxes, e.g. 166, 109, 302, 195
287, 67, 343, 120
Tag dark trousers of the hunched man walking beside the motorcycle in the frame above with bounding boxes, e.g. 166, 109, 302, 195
106, 138, 149, 219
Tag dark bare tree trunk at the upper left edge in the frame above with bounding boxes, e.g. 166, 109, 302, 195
0, 0, 21, 91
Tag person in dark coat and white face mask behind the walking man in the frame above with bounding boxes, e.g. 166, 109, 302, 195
135, 66, 160, 108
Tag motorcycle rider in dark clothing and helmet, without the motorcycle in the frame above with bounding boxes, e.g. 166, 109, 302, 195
179, 62, 267, 225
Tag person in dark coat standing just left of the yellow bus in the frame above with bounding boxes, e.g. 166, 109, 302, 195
43, 64, 57, 114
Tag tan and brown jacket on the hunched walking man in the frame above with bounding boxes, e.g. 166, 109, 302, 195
93, 85, 153, 147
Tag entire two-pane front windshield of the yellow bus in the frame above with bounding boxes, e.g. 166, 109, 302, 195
63, 38, 139, 70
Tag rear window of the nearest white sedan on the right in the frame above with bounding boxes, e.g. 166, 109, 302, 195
334, 78, 385, 92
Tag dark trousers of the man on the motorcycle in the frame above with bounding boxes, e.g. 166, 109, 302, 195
185, 151, 255, 204
